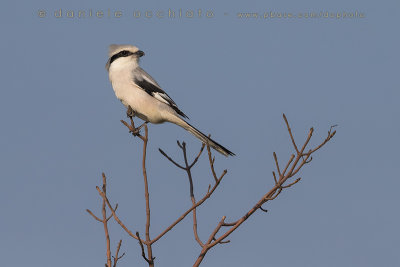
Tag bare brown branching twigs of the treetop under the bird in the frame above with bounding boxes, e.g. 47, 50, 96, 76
87, 114, 336, 267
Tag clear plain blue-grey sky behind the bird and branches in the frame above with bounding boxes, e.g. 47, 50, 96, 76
0, 0, 400, 267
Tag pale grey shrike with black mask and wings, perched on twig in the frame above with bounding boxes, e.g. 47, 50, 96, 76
106, 44, 235, 156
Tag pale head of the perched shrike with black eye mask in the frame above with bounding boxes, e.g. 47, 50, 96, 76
106, 44, 144, 70
